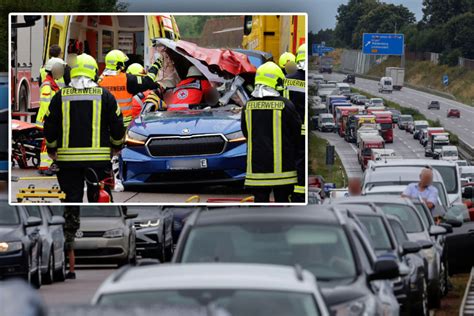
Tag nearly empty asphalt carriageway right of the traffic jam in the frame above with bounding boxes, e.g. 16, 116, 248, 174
325, 73, 474, 147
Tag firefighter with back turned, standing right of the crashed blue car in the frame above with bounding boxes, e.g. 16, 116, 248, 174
241, 62, 304, 203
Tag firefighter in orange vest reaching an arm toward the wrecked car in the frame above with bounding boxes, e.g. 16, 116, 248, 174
99, 49, 163, 127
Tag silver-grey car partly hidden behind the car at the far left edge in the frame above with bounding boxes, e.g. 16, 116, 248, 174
25, 206, 66, 284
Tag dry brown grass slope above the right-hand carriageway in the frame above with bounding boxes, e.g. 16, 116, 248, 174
367, 57, 474, 106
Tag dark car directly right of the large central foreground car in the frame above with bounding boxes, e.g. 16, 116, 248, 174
344, 204, 429, 316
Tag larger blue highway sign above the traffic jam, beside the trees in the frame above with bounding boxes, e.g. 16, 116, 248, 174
362, 33, 405, 55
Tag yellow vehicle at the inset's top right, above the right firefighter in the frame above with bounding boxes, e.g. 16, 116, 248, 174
242, 15, 307, 60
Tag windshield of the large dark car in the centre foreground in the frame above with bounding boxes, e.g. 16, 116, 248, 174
182, 223, 356, 281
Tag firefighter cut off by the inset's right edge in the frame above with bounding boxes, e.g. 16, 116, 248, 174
284, 44, 307, 202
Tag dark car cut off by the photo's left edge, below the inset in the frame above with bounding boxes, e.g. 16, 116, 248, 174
0, 200, 41, 288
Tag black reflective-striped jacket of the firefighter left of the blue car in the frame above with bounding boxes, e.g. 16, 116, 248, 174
44, 87, 125, 167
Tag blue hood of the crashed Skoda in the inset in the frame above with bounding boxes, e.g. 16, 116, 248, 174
130, 110, 240, 137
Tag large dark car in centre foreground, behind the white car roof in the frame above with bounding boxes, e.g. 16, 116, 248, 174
173, 206, 399, 315
